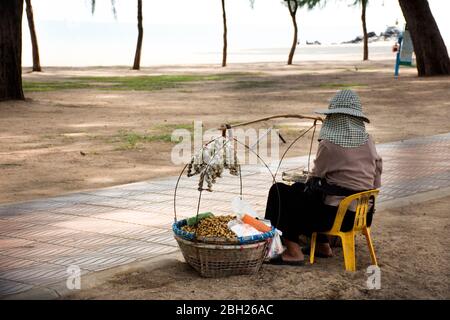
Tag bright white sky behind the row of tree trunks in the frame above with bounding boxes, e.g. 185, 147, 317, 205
23, 0, 450, 66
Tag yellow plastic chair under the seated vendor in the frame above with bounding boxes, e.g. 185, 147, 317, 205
309, 189, 380, 271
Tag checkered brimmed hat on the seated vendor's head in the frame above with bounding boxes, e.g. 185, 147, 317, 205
315, 89, 370, 123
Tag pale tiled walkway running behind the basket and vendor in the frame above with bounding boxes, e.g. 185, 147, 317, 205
0, 133, 450, 297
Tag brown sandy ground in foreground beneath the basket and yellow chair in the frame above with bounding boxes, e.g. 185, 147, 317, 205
67, 197, 450, 300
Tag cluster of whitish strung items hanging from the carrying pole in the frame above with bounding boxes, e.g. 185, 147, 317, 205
187, 137, 240, 191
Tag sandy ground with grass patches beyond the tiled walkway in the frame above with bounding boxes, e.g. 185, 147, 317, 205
0, 61, 450, 203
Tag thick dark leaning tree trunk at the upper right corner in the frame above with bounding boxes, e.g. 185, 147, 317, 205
399, 0, 450, 77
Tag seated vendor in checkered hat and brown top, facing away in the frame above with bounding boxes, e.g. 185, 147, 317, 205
265, 90, 382, 265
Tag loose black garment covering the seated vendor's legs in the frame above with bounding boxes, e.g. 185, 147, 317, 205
265, 183, 362, 242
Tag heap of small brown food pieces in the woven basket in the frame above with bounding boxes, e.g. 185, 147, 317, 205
181, 215, 237, 240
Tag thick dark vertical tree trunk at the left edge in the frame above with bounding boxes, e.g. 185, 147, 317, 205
0, 0, 24, 100
